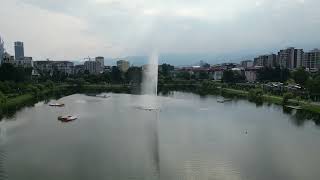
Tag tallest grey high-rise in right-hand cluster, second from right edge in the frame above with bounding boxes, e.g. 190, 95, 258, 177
278, 47, 303, 69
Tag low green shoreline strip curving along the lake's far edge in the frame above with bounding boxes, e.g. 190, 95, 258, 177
0, 83, 320, 118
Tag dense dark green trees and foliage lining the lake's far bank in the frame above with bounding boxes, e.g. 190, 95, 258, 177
0, 64, 320, 118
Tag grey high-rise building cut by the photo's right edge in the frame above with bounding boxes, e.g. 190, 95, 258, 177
303, 49, 320, 71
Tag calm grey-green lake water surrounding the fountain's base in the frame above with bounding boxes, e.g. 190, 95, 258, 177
0, 93, 320, 180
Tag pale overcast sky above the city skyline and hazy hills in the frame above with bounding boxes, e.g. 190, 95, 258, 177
0, 0, 320, 64
